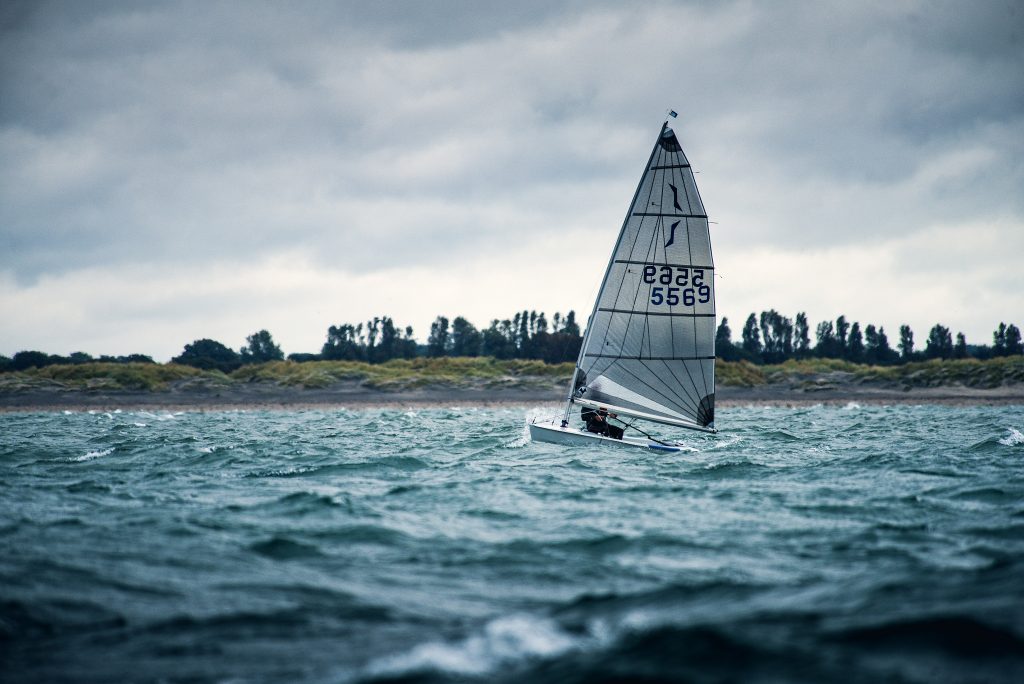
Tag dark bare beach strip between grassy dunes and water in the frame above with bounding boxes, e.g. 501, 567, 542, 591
0, 384, 1024, 413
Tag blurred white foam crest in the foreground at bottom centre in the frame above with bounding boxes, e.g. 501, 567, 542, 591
368, 615, 583, 677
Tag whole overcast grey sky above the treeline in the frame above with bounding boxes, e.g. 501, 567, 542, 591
0, 0, 1024, 360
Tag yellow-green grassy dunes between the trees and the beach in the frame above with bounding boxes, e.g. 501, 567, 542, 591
0, 356, 1024, 392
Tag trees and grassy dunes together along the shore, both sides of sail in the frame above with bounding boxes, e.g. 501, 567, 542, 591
0, 309, 1024, 392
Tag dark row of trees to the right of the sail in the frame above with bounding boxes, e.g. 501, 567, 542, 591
715, 309, 1024, 366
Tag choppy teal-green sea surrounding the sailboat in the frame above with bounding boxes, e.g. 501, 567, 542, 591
0, 404, 1024, 683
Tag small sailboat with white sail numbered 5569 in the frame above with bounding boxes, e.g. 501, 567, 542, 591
529, 112, 717, 451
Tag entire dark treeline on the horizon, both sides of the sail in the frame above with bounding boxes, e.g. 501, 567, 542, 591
0, 309, 1024, 373
